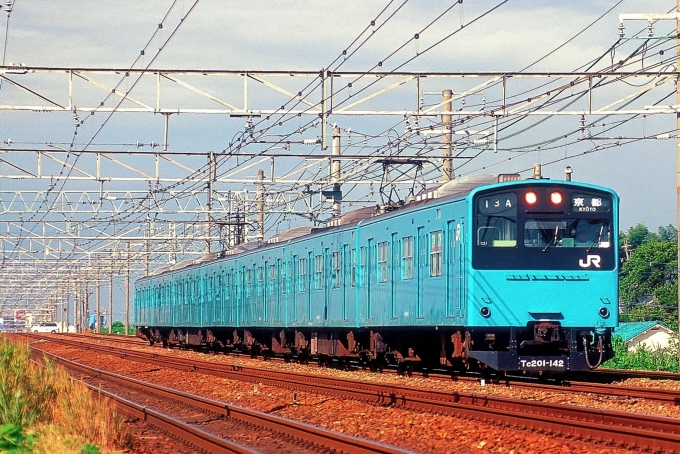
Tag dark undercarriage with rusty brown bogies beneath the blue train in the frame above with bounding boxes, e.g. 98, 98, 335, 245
137, 322, 613, 375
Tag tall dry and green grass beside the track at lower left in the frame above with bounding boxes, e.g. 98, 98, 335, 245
0, 336, 133, 454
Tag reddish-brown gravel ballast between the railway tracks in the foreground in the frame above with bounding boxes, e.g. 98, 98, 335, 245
31, 340, 680, 454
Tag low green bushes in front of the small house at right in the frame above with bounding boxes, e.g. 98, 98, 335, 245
602, 336, 678, 372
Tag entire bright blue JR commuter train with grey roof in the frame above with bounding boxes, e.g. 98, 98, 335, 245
135, 175, 619, 374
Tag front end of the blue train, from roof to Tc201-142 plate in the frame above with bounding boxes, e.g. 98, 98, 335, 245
463, 179, 618, 374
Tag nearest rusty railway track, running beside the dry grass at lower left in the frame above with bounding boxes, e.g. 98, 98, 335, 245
36, 349, 411, 454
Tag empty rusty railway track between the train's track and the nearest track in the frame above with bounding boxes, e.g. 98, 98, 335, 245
29, 339, 680, 452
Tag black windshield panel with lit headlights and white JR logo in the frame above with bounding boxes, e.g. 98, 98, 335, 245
472, 184, 617, 270
